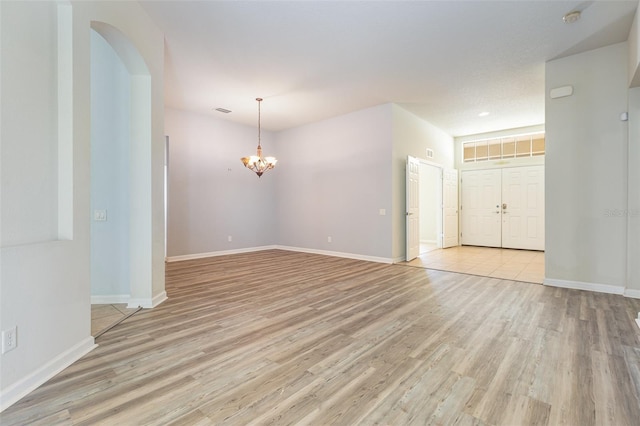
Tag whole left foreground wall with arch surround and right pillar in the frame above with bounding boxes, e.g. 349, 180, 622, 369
0, 1, 165, 410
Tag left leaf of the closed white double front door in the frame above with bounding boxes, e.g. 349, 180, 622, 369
461, 169, 502, 247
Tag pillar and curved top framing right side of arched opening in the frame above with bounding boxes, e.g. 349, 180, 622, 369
86, 2, 166, 308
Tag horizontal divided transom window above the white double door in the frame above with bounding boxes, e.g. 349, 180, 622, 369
462, 133, 544, 163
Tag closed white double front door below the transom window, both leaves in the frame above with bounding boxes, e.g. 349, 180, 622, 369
460, 166, 544, 250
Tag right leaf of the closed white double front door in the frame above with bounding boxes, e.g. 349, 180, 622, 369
501, 166, 544, 250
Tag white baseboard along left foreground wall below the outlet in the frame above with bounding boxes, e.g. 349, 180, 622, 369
0, 336, 98, 412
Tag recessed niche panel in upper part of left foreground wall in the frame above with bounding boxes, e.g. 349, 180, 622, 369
1, 3, 58, 247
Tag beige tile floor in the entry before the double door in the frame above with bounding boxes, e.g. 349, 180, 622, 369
407, 246, 544, 284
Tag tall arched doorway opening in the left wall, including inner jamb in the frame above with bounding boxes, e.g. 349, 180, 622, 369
91, 22, 166, 328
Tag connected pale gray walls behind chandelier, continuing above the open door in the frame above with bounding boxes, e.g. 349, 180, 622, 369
165, 104, 453, 262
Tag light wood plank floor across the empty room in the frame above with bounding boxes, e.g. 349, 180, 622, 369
0, 250, 640, 426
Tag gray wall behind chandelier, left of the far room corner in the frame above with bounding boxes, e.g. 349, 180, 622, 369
165, 108, 276, 257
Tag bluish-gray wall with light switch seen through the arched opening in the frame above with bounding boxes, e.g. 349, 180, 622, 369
91, 30, 131, 302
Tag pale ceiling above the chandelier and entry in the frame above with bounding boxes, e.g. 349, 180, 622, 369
140, 0, 638, 136
